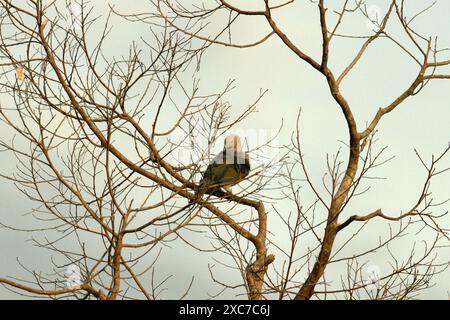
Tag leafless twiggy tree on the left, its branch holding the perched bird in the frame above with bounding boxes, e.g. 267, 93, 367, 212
0, 1, 284, 299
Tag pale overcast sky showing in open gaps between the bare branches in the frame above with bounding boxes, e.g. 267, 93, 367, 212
0, 0, 450, 299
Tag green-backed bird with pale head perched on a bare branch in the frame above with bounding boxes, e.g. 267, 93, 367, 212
196, 135, 250, 198
